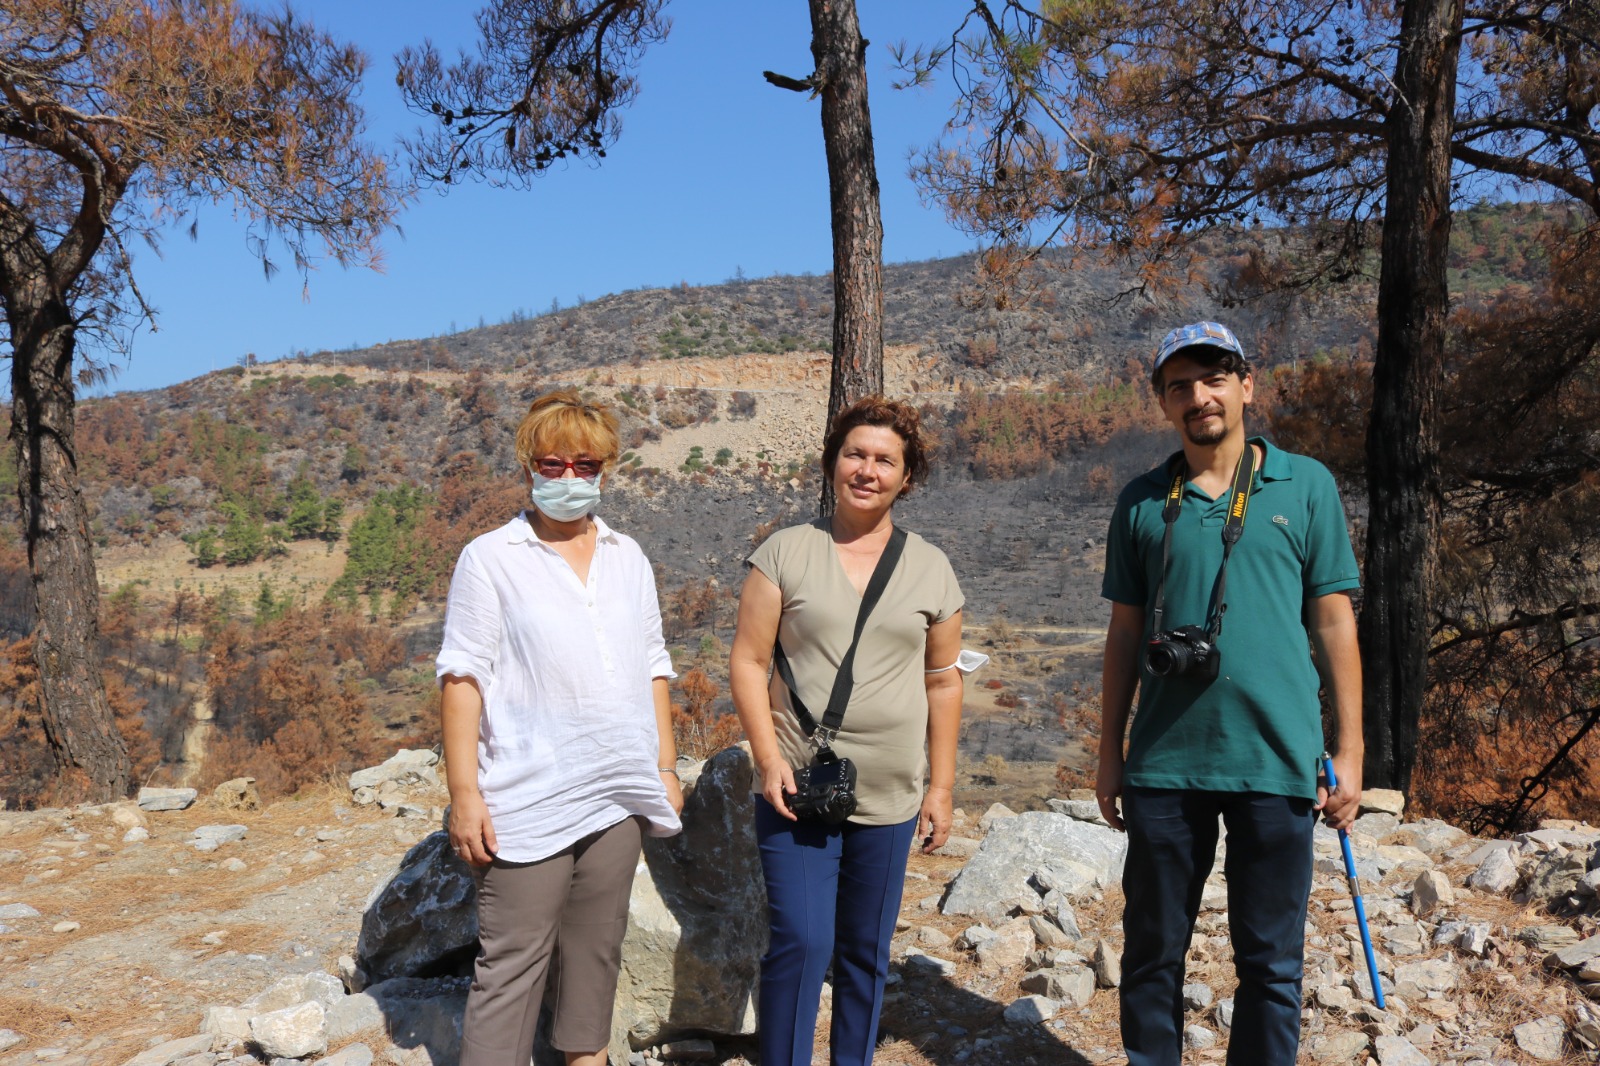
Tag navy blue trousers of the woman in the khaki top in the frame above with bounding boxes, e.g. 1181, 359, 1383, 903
755, 797, 917, 1066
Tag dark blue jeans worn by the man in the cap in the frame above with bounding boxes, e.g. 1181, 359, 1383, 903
1122, 786, 1315, 1066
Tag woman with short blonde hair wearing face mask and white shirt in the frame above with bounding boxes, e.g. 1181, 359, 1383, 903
437, 391, 683, 1066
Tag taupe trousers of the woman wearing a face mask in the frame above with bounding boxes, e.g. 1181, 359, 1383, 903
461, 818, 640, 1066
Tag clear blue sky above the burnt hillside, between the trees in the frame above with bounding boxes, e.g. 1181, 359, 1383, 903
100, 0, 973, 395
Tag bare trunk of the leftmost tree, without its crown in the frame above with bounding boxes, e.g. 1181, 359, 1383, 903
0, 204, 133, 802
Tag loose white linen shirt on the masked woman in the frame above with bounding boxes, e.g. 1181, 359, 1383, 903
437, 515, 682, 863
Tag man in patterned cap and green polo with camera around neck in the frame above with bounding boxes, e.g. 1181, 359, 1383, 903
1094, 322, 1362, 1066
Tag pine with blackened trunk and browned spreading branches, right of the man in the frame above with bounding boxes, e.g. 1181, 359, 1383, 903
901, 0, 1600, 789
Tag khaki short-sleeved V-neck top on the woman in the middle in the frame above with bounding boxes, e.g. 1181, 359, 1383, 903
749, 519, 963, 826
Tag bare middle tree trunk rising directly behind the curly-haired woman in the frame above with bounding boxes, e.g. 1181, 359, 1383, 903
766, 0, 883, 515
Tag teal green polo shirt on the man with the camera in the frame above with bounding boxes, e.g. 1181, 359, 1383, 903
1101, 437, 1360, 799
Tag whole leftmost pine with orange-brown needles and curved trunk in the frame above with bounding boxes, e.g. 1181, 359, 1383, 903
0, 0, 398, 800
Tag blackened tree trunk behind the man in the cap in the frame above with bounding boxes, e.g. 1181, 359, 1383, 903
1360, 0, 1462, 791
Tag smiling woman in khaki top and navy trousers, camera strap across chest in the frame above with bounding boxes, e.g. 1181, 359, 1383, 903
730, 397, 962, 1066
